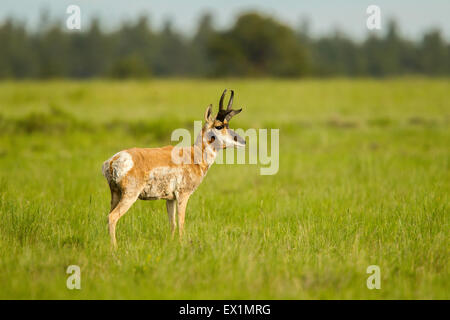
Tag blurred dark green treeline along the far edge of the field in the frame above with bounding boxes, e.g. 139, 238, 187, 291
0, 13, 450, 79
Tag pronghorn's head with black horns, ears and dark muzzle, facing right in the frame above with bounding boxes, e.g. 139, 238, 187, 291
203, 89, 245, 150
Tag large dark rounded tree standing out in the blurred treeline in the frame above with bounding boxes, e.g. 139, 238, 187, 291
209, 13, 308, 77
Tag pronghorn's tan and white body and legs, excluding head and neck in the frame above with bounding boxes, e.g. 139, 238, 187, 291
103, 134, 214, 246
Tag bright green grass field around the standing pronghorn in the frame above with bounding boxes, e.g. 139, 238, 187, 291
0, 78, 450, 299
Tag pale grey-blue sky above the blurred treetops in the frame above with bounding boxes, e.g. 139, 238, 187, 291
0, 0, 450, 39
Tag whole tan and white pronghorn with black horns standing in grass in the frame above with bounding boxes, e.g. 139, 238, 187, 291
102, 89, 245, 246
